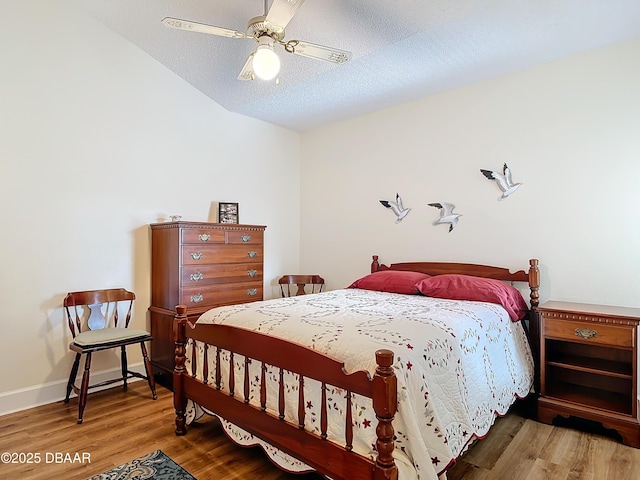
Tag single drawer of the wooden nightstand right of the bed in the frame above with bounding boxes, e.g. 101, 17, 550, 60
542, 314, 634, 348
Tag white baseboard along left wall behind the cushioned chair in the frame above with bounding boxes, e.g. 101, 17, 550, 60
0, 362, 145, 415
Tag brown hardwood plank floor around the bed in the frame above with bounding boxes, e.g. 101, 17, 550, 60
0, 382, 640, 480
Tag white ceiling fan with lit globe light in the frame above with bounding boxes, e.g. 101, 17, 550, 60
162, 0, 351, 82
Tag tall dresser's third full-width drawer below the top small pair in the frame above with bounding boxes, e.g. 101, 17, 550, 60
180, 282, 263, 311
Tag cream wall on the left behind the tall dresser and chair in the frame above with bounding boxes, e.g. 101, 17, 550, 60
0, 0, 300, 411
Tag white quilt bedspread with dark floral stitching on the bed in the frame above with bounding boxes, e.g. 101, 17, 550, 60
187, 289, 533, 480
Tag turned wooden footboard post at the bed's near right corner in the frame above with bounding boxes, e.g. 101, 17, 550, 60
373, 348, 398, 480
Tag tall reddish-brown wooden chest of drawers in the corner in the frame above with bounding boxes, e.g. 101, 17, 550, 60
149, 222, 266, 387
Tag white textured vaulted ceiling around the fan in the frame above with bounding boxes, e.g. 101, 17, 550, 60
74, 0, 640, 131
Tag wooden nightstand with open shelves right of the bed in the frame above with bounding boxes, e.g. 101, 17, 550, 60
538, 301, 640, 448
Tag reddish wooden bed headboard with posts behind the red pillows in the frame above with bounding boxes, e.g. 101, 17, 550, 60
371, 255, 540, 310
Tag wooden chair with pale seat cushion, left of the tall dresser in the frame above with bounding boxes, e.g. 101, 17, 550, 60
63, 288, 157, 423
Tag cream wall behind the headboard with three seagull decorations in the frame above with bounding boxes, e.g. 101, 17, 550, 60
301, 36, 640, 306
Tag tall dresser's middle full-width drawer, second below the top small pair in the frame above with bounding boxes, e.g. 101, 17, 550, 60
180, 263, 263, 287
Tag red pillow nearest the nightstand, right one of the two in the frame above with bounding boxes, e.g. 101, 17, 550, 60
416, 274, 529, 322
